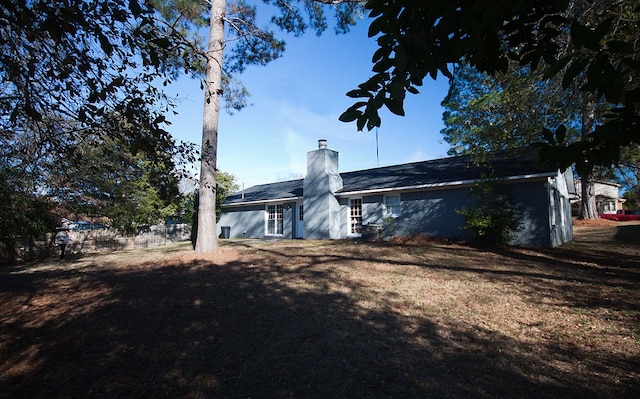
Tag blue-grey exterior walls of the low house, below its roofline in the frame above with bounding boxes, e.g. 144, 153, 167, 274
218, 174, 573, 247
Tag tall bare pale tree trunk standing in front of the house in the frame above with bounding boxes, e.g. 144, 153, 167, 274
195, 0, 226, 253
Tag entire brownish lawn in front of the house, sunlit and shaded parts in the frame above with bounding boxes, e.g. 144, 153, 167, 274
0, 225, 640, 398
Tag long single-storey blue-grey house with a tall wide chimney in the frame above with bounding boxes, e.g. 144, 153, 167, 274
218, 140, 574, 247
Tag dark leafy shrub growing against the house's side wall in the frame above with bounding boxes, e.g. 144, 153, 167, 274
456, 175, 522, 244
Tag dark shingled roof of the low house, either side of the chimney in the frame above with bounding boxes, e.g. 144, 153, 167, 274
225, 149, 557, 205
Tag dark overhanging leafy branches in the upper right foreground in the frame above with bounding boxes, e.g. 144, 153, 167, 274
340, 0, 640, 170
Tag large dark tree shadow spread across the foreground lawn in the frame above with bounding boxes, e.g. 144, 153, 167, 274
0, 245, 638, 398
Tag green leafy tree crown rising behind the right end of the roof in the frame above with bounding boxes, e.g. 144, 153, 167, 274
441, 62, 582, 157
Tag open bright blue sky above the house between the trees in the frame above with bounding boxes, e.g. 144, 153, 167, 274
167, 19, 449, 187
